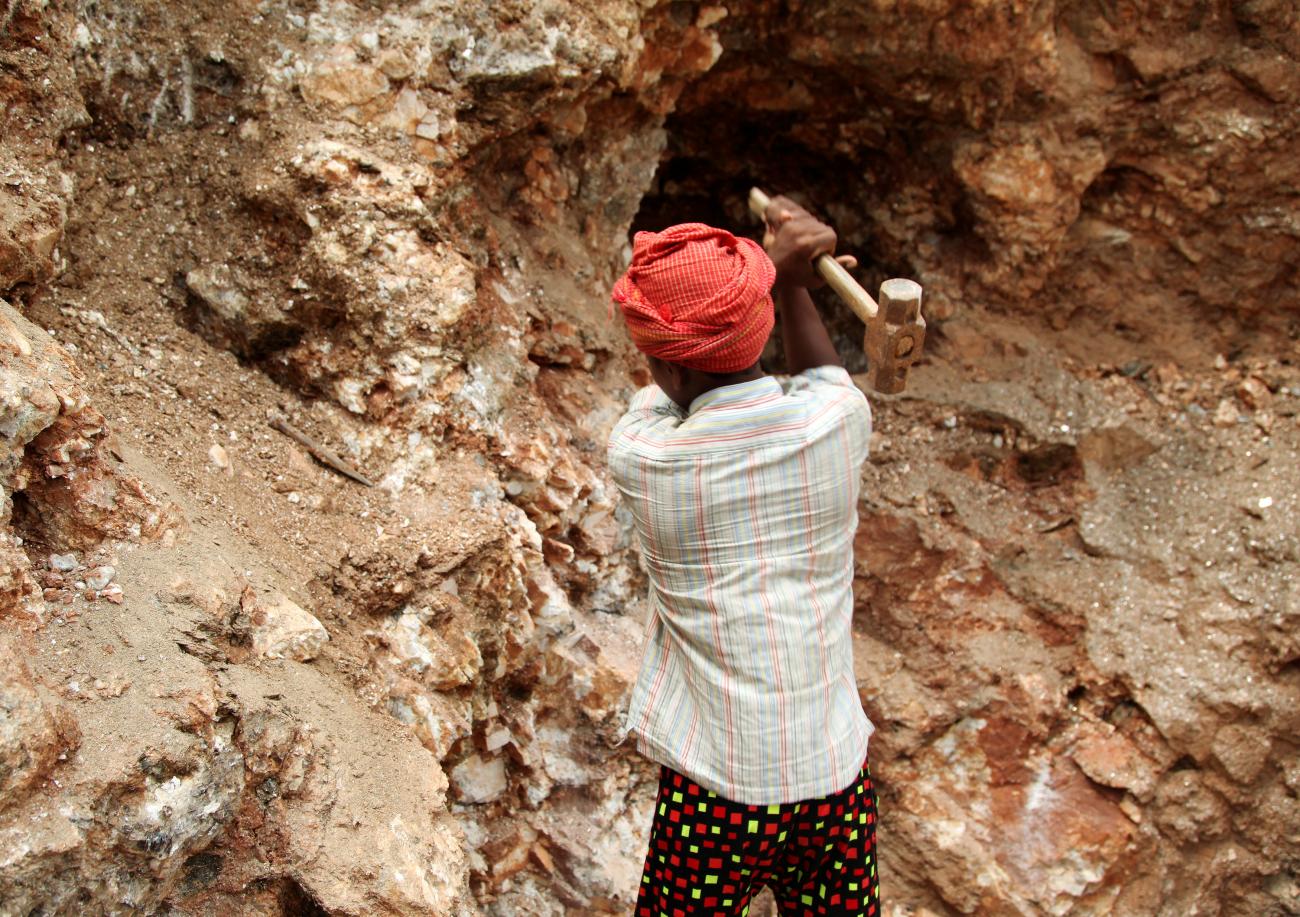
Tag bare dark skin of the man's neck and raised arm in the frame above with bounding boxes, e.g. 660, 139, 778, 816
646, 196, 858, 410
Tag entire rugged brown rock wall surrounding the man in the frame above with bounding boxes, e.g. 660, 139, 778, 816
0, 0, 1300, 917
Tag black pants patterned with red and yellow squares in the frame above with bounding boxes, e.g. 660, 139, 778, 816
636, 762, 880, 917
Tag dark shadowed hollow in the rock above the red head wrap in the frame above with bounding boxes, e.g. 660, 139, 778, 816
628, 18, 946, 372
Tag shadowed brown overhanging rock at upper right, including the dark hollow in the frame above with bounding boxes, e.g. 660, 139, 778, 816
646, 0, 1300, 337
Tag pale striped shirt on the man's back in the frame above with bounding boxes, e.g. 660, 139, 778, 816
608, 367, 872, 805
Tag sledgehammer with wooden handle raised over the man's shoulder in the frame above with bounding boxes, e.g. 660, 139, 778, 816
749, 187, 926, 395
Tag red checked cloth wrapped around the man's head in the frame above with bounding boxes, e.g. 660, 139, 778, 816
614, 222, 776, 373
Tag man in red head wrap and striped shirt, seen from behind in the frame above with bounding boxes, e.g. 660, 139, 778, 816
610, 198, 879, 917
